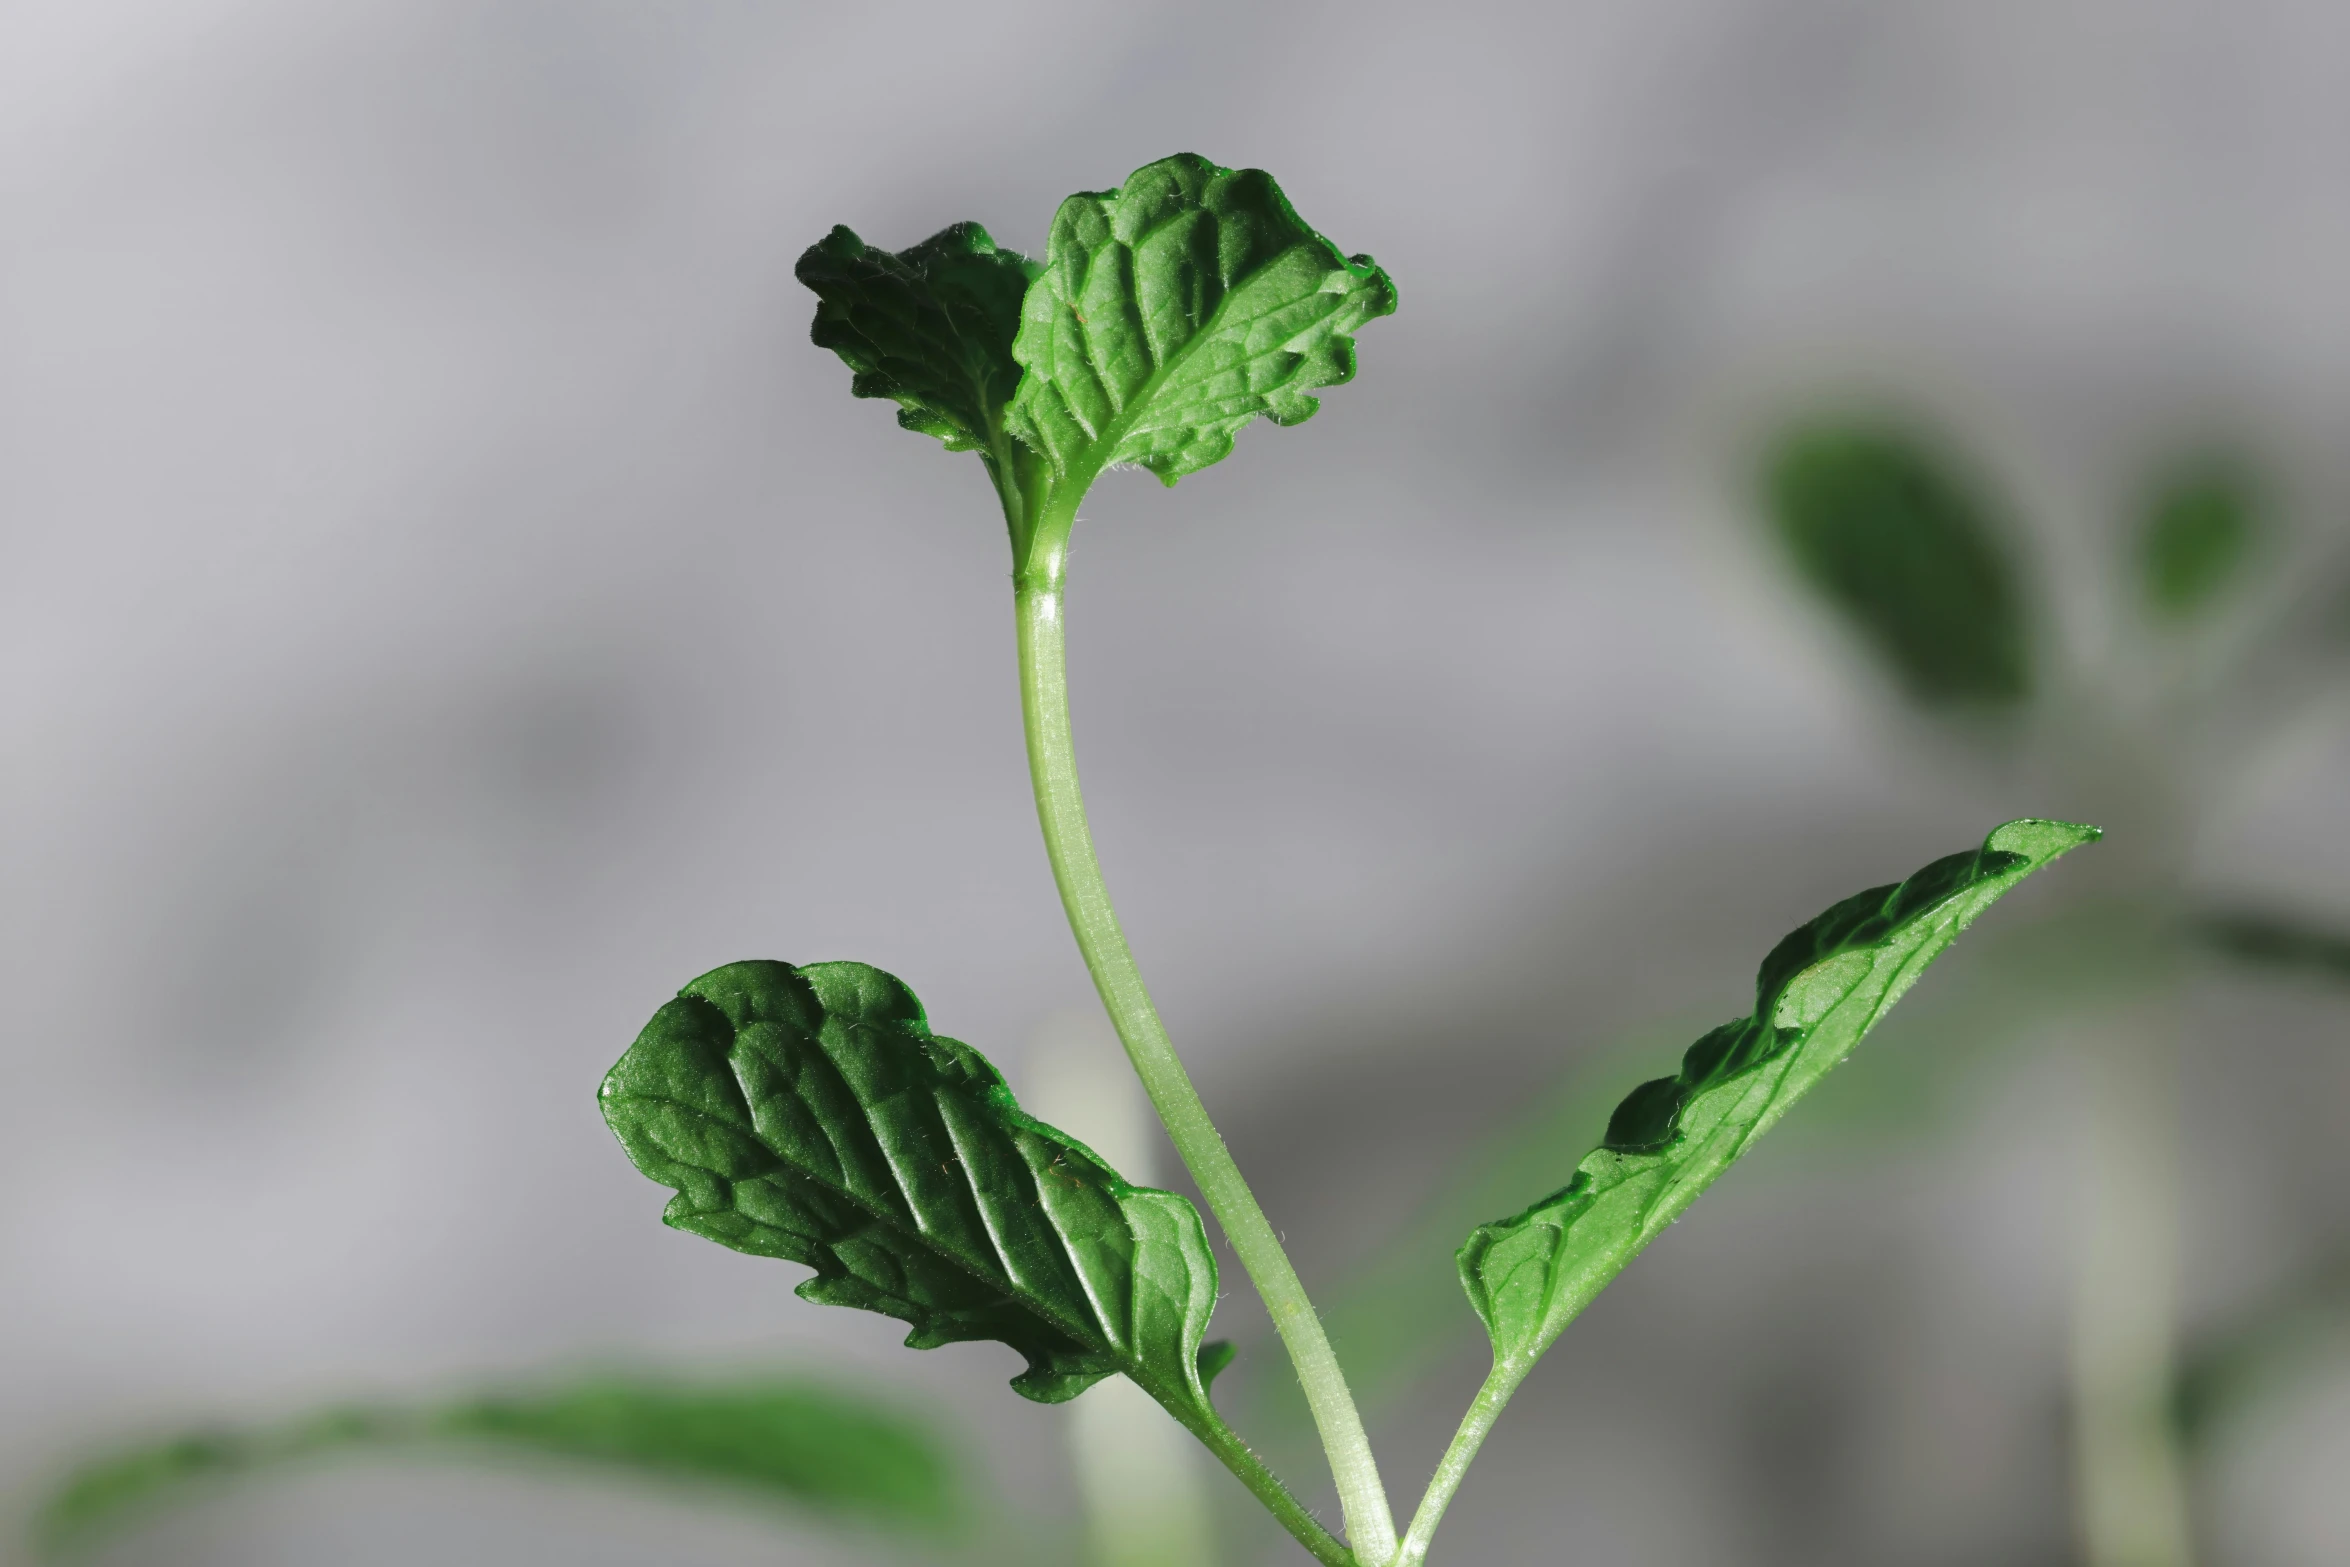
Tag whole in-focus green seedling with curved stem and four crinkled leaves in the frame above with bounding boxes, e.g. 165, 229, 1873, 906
602, 155, 2099, 1567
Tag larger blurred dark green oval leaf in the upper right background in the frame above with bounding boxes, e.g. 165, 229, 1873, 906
1765, 425, 2030, 705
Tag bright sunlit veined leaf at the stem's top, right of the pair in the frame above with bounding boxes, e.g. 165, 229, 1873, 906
1011, 153, 1396, 491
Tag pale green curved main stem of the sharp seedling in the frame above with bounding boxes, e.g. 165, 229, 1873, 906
1013, 515, 1396, 1567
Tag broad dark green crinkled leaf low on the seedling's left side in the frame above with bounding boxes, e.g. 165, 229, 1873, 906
602, 963, 1215, 1419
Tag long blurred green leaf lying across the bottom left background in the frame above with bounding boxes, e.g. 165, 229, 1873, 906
35, 1377, 964, 1555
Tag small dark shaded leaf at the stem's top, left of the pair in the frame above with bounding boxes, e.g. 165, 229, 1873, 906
794, 223, 1036, 479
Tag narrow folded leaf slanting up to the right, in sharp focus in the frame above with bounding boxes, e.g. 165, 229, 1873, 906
1459, 820, 2099, 1367
